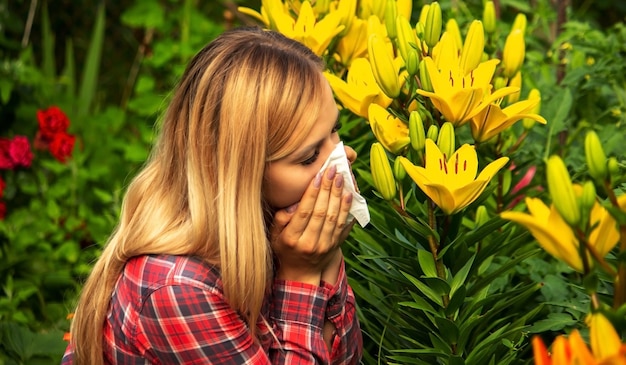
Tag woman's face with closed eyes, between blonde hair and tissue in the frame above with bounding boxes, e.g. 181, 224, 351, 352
263, 83, 356, 209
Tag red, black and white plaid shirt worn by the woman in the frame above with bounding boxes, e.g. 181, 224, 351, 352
62, 256, 362, 365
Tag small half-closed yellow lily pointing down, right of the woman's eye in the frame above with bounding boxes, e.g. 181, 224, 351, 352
368, 104, 411, 155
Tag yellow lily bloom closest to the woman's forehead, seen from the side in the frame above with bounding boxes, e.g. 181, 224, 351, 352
324, 58, 392, 118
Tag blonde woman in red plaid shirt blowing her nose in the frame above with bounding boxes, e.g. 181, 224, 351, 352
63, 28, 362, 365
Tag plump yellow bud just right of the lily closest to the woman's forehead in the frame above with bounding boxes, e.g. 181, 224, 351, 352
367, 33, 400, 99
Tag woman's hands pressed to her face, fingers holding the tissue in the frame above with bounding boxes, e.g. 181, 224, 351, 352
270, 166, 352, 285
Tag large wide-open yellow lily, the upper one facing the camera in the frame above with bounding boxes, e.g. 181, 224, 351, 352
417, 56, 517, 127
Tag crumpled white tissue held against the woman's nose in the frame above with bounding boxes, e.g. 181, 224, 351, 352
320, 142, 370, 227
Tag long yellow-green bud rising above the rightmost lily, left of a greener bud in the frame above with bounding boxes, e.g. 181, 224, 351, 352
546, 155, 580, 227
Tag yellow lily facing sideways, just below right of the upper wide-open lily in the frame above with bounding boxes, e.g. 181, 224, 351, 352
470, 99, 547, 142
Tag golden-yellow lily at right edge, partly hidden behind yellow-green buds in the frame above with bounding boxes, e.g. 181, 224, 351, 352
500, 185, 619, 272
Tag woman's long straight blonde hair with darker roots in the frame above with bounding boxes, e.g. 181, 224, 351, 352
71, 28, 324, 365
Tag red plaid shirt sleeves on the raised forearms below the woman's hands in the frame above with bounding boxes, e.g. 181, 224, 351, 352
270, 256, 363, 365
